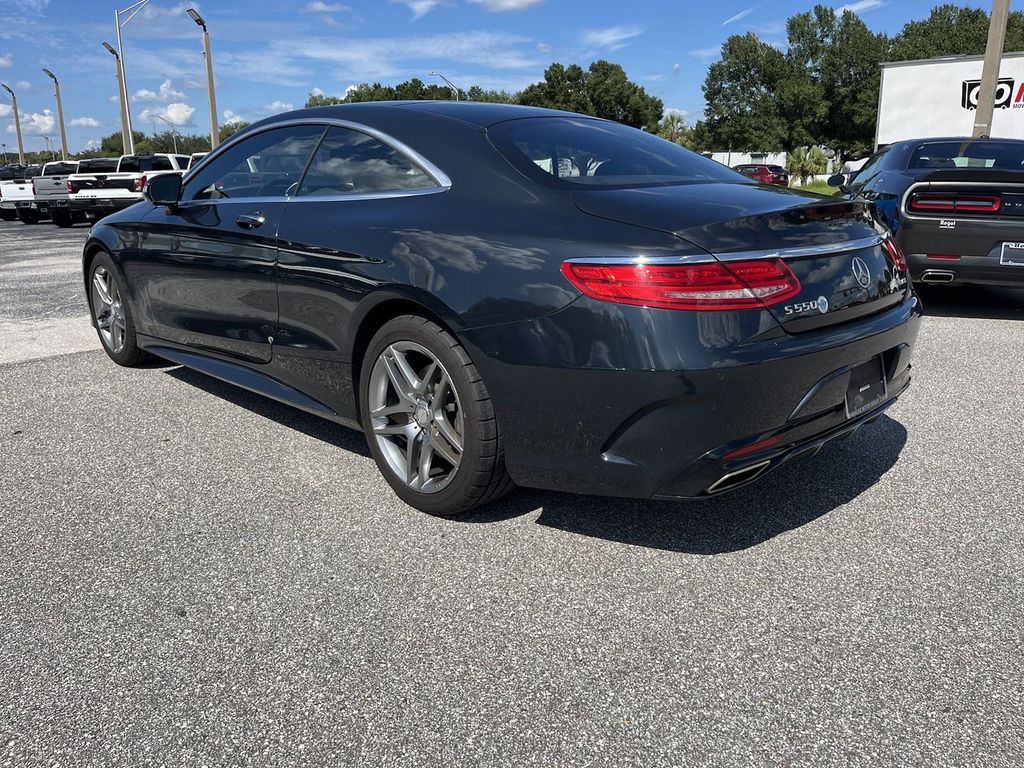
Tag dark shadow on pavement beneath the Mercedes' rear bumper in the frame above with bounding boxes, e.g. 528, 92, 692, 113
453, 416, 906, 555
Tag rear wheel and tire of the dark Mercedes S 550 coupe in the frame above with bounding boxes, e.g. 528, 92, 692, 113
359, 315, 512, 515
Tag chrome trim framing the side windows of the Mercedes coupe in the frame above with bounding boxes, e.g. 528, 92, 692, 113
181, 118, 452, 198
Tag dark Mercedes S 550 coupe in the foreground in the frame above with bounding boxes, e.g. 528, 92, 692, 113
83, 101, 921, 514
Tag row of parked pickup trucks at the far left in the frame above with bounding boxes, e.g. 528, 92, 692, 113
0, 153, 206, 227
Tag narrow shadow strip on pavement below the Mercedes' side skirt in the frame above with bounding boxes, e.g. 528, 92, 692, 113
165, 364, 370, 457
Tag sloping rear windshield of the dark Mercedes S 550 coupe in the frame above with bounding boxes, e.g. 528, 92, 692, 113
487, 118, 749, 187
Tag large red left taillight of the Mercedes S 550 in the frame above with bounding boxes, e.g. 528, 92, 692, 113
562, 259, 800, 310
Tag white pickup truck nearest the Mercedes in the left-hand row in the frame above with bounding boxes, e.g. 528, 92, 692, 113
68, 153, 188, 219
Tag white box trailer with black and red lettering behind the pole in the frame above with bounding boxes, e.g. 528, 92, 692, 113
874, 53, 1024, 147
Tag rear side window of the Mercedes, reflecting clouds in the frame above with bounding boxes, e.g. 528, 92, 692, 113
298, 128, 437, 197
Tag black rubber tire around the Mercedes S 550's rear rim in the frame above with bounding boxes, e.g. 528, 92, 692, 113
359, 314, 514, 516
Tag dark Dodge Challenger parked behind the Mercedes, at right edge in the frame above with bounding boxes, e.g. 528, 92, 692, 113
828, 137, 1024, 288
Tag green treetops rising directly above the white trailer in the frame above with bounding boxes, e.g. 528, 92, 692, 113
890, 3, 1024, 61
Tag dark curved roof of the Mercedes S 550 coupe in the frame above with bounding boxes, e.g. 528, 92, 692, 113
246, 100, 600, 128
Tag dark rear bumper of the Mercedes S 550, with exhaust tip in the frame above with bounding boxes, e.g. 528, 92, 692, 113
463, 297, 921, 499
